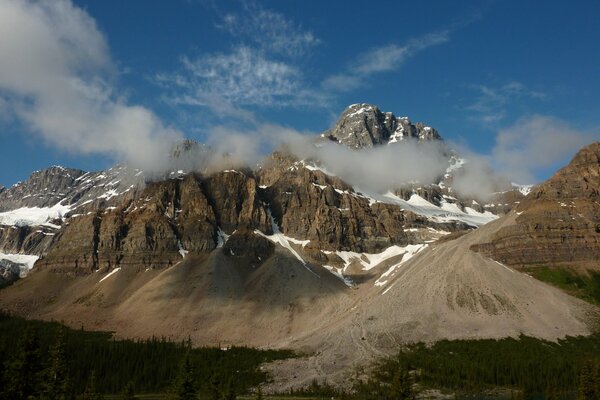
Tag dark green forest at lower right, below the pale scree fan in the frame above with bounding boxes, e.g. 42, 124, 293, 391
355, 334, 600, 400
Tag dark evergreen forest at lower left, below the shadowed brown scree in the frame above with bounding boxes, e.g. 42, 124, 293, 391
0, 314, 293, 400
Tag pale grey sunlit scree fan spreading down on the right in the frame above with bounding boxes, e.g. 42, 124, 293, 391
264, 214, 599, 388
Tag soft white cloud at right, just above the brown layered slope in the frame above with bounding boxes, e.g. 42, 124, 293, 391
491, 115, 600, 183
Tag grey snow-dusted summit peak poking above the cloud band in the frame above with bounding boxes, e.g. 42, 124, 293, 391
322, 103, 442, 148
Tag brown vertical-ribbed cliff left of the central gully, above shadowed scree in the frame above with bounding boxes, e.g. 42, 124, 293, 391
37, 171, 271, 273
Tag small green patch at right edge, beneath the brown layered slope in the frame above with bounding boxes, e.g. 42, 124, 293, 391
525, 267, 600, 305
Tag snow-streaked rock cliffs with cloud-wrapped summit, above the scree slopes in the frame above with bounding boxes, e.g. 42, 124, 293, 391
0, 104, 510, 282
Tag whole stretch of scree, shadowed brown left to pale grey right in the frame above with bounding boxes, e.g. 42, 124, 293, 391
0, 214, 598, 389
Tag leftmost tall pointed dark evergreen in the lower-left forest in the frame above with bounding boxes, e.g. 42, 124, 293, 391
6, 328, 42, 400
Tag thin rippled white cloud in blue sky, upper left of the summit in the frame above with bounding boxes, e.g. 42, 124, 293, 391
154, 46, 328, 115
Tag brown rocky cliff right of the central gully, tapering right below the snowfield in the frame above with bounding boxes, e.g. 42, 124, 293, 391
257, 153, 466, 253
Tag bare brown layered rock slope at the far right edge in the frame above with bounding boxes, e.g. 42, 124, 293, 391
474, 142, 600, 270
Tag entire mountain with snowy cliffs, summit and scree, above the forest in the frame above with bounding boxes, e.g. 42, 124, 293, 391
0, 104, 600, 390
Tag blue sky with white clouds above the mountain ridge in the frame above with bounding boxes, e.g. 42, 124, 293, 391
0, 0, 600, 186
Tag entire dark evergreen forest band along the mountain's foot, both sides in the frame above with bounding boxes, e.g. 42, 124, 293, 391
0, 314, 600, 400
